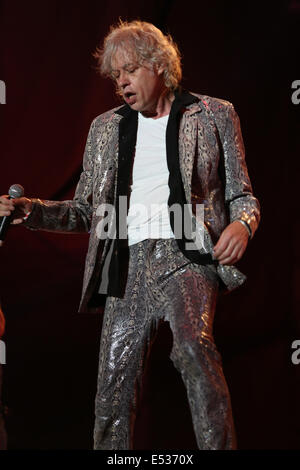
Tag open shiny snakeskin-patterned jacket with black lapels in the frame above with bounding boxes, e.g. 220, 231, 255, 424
25, 94, 260, 312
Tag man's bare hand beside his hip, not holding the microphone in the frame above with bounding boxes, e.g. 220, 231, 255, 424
214, 220, 249, 265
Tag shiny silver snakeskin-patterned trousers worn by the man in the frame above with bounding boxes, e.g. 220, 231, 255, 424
94, 239, 235, 450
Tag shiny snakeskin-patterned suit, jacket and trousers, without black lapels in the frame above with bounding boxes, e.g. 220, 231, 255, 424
26, 94, 260, 449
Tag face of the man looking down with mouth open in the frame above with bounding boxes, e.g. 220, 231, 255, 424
112, 51, 165, 113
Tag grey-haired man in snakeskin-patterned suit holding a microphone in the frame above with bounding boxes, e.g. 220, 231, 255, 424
0, 21, 259, 450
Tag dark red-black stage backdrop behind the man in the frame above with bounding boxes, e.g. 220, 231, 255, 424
0, 0, 300, 449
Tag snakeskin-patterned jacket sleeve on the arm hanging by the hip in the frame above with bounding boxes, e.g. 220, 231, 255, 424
221, 103, 260, 236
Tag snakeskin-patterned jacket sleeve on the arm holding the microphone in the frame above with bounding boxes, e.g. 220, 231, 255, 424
24, 120, 95, 233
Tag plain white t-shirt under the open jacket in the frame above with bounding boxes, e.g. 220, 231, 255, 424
127, 113, 174, 245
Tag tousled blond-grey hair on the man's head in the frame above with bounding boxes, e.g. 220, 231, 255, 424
94, 20, 182, 90
